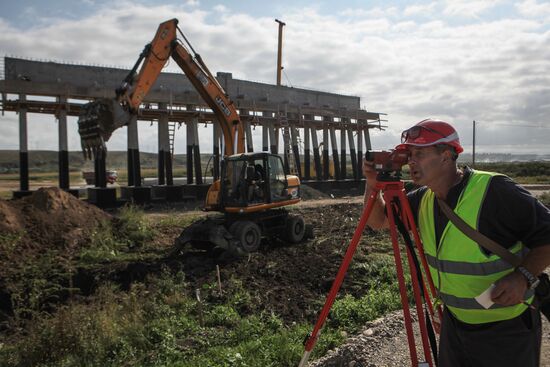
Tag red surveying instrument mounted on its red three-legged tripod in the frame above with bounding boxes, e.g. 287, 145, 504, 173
299, 150, 442, 367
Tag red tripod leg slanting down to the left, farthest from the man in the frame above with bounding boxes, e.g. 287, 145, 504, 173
299, 189, 380, 367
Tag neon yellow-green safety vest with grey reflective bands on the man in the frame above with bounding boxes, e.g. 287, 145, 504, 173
418, 171, 533, 324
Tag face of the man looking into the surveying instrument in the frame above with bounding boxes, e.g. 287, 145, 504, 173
409, 146, 444, 186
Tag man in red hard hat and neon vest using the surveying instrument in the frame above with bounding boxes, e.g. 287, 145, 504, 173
363, 119, 550, 367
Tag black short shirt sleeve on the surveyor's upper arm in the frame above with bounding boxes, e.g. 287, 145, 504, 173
478, 176, 550, 248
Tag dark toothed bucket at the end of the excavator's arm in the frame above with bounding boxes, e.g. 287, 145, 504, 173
78, 98, 130, 159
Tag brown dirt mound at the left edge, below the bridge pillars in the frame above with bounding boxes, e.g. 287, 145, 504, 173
0, 187, 111, 252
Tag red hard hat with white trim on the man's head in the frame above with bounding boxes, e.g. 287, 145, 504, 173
395, 119, 464, 154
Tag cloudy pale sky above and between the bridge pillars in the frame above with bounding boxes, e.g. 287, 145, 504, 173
0, 0, 550, 154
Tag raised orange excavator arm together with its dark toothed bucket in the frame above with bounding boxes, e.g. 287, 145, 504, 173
78, 19, 245, 159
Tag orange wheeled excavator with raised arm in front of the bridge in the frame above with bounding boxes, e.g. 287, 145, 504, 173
78, 19, 312, 254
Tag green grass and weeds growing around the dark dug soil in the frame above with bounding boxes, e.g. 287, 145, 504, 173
0, 206, 410, 367
